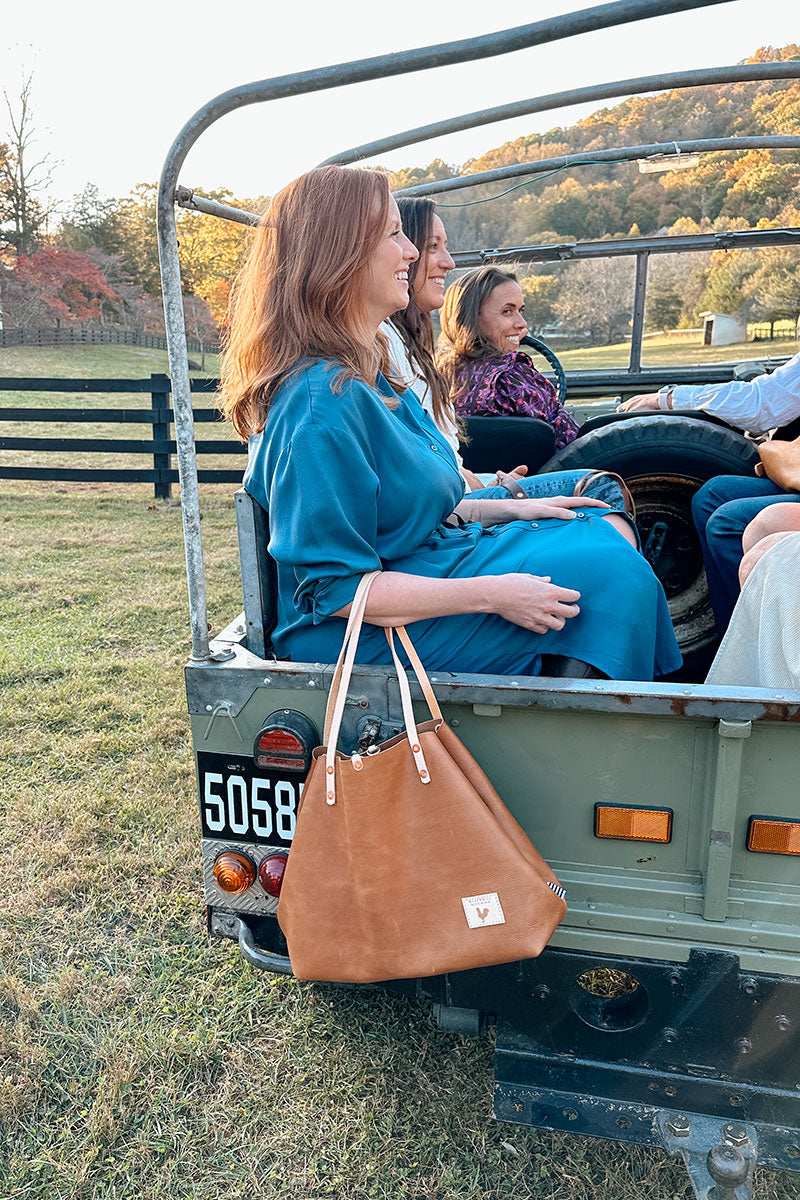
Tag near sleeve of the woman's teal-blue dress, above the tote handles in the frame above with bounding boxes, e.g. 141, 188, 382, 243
270, 422, 381, 624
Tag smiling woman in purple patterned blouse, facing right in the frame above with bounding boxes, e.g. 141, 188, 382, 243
437, 266, 579, 450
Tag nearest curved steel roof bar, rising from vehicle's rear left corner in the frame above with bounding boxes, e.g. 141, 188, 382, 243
156, 0, 729, 661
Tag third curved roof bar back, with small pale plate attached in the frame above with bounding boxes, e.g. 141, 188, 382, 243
395, 134, 800, 196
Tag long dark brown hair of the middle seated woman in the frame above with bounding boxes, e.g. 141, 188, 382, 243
392, 196, 455, 440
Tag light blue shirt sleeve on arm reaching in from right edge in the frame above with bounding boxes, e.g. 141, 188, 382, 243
672, 354, 800, 433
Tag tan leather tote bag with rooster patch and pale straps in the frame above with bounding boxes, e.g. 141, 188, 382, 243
278, 572, 566, 983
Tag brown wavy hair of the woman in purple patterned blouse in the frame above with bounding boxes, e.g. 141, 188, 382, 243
437, 266, 518, 403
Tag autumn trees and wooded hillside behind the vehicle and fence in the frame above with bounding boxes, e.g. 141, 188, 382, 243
0, 51, 800, 342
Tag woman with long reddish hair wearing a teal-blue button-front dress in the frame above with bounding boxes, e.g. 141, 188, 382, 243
222, 167, 680, 679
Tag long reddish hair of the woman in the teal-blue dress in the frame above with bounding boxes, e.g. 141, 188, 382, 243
219, 167, 402, 442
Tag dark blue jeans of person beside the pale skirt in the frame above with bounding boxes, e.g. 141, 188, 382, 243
692, 475, 800, 634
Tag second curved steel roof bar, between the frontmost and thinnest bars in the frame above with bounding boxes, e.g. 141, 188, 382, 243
321, 59, 800, 166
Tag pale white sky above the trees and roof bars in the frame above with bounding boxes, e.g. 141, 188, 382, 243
0, 0, 800, 211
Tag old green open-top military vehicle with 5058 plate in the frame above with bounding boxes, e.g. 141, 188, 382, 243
160, 0, 800, 1200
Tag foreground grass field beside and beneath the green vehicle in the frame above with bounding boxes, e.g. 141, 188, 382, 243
0, 482, 800, 1200
